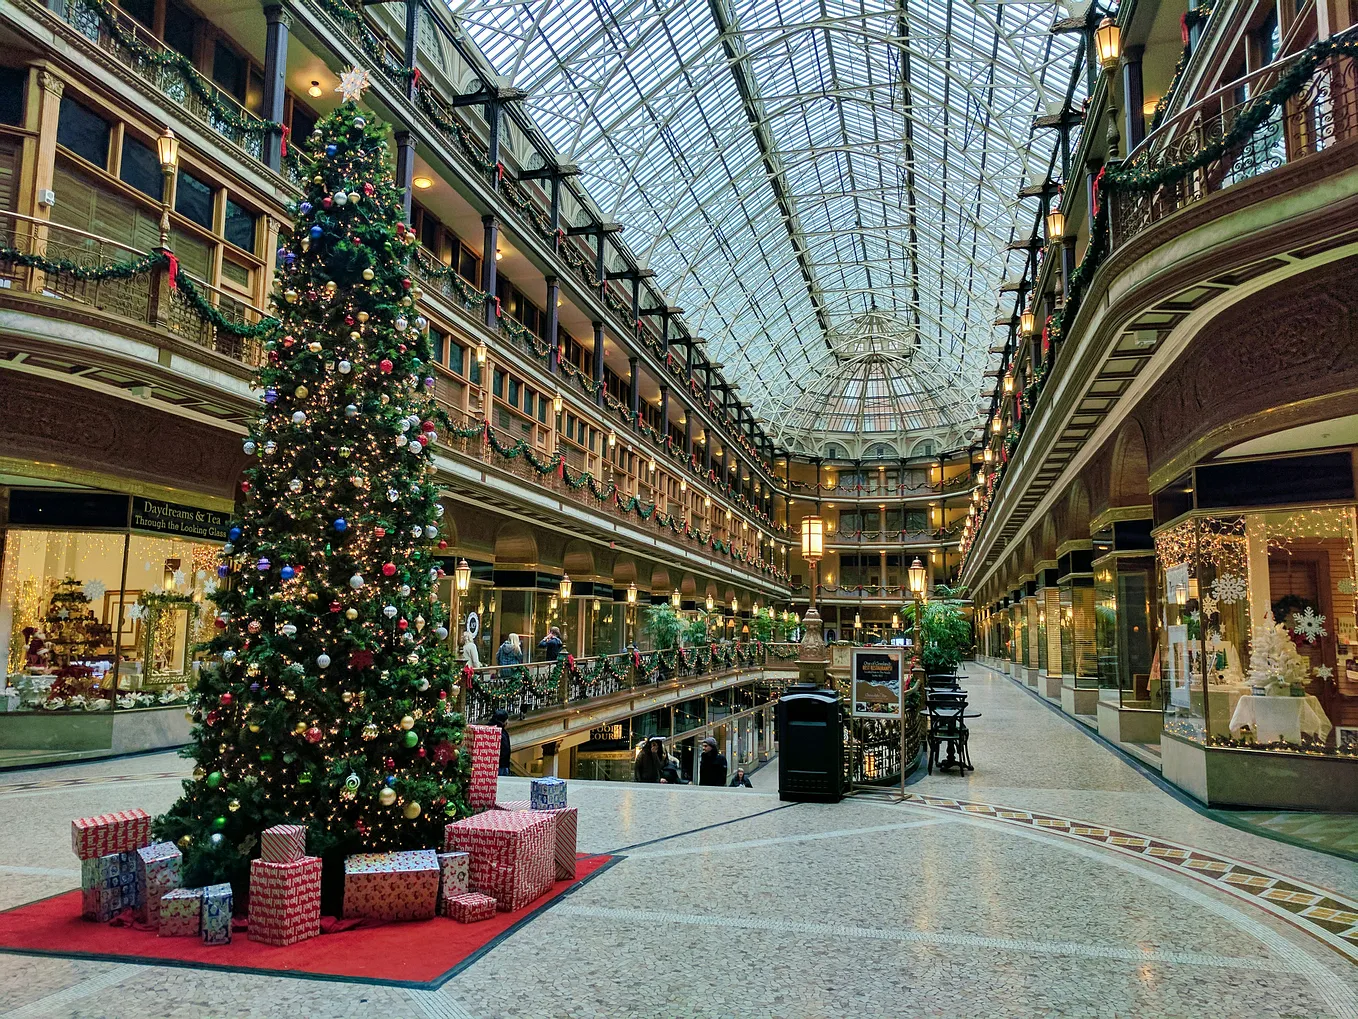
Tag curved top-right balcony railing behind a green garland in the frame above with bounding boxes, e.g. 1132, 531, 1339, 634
1111, 41, 1358, 249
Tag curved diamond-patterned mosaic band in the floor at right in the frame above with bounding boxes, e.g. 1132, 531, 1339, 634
906, 792, 1358, 965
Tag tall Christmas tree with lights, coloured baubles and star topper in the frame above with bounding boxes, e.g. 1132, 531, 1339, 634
156, 72, 470, 909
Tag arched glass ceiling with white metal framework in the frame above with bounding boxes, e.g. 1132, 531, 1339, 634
454, 0, 1077, 455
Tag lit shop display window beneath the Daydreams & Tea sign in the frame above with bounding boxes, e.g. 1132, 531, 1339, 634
0, 529, 219, 711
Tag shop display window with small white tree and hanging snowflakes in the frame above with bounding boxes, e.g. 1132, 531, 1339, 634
1152, 505, 1358, 755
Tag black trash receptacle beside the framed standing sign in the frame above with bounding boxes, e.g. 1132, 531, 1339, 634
778, 683, 845, 803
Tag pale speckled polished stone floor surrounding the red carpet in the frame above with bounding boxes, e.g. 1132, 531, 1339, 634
0, 670, 1358, 1019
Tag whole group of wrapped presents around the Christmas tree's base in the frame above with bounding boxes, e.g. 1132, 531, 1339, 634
71, 726, 577, 946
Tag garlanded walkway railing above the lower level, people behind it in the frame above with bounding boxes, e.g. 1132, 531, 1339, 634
462, 641, 799, 721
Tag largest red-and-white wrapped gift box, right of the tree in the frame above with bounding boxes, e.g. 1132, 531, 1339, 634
443, 810, 557, 913
